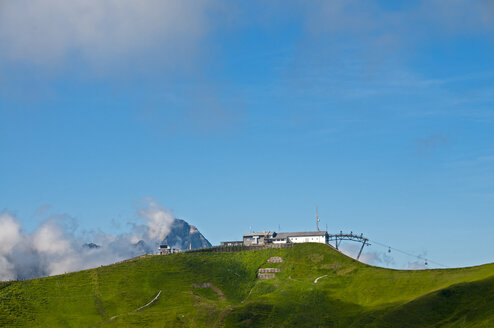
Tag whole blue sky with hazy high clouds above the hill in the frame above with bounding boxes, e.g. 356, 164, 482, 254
0, 0, 494, 267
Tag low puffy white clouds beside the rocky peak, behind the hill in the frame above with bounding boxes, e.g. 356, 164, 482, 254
0, 199, 174, 280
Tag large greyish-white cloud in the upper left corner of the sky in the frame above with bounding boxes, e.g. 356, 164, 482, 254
0, 0, 220, 65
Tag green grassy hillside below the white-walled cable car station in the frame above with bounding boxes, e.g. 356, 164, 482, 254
0, 244, 494, 327
